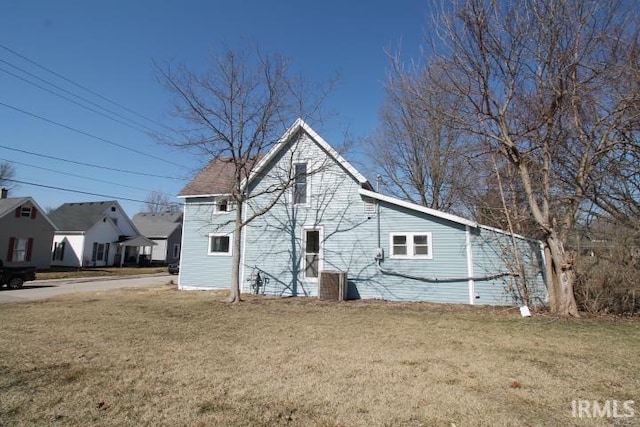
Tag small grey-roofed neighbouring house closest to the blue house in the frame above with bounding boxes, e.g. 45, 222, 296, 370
132, 212, 182, 264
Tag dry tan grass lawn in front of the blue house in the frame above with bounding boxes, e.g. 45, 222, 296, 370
0, 287, 640, 426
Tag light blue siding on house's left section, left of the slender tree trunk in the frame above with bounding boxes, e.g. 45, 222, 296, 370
180, 198, 235, 289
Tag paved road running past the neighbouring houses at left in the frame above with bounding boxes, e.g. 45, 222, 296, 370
0, 273, 176, 304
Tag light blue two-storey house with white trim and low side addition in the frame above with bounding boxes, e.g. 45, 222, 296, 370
178, 119, 546, 305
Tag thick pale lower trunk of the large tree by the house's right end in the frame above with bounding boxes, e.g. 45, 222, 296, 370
545, 233, 579, 317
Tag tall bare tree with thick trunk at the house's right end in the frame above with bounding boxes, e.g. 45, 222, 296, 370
424, 0, 638, 315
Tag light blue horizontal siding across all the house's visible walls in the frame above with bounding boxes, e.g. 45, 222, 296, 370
180, 125, 545, 304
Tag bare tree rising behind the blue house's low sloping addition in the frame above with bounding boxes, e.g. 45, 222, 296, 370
369, 54, 473, 212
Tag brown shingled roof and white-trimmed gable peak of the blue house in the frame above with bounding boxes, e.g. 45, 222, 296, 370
178, 118, 371, 198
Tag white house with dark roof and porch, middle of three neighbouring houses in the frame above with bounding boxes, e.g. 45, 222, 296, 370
49, 200, 155, 267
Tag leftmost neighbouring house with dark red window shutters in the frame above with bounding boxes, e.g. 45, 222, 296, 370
0, 189, 56, 269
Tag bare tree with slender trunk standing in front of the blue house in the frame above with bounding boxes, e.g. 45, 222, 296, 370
156, 48, 326, 303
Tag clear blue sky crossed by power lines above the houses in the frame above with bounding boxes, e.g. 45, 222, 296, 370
0, 0, 429, 216
